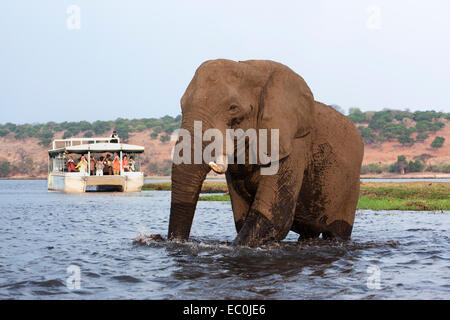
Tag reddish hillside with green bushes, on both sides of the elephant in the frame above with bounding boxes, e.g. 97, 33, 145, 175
0, 109, 450, 177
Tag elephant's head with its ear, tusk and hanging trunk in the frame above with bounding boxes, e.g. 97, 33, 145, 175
168, 60, 314, 239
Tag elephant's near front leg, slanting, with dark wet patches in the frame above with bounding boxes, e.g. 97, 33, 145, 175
234, 140, 306, 246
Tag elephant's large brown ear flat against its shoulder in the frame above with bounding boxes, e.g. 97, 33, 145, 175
258, 66, 314, 162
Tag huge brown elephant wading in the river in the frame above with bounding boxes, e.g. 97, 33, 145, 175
168, 59, 364, 247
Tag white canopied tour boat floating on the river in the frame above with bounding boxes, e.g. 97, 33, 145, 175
48, 138, 144, 193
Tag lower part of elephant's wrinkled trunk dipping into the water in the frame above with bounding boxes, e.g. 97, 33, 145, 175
168, 164, 210, 240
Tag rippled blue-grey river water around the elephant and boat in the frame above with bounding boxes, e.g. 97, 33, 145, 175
0, 180, 450, 299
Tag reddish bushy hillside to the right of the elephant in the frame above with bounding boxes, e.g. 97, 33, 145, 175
348, 109, 450, 173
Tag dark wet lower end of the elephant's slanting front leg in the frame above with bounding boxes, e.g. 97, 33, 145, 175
233, 210, 278, 247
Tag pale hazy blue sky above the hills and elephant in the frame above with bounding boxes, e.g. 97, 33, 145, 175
0, 0, 450, 123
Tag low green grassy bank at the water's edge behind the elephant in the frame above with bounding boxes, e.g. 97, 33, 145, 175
145, 181, 450, 211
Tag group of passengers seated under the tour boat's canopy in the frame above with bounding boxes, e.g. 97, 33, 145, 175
66, 154, 136, 176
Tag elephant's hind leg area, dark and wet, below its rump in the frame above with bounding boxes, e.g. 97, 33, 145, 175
292, 142, 359, 239
